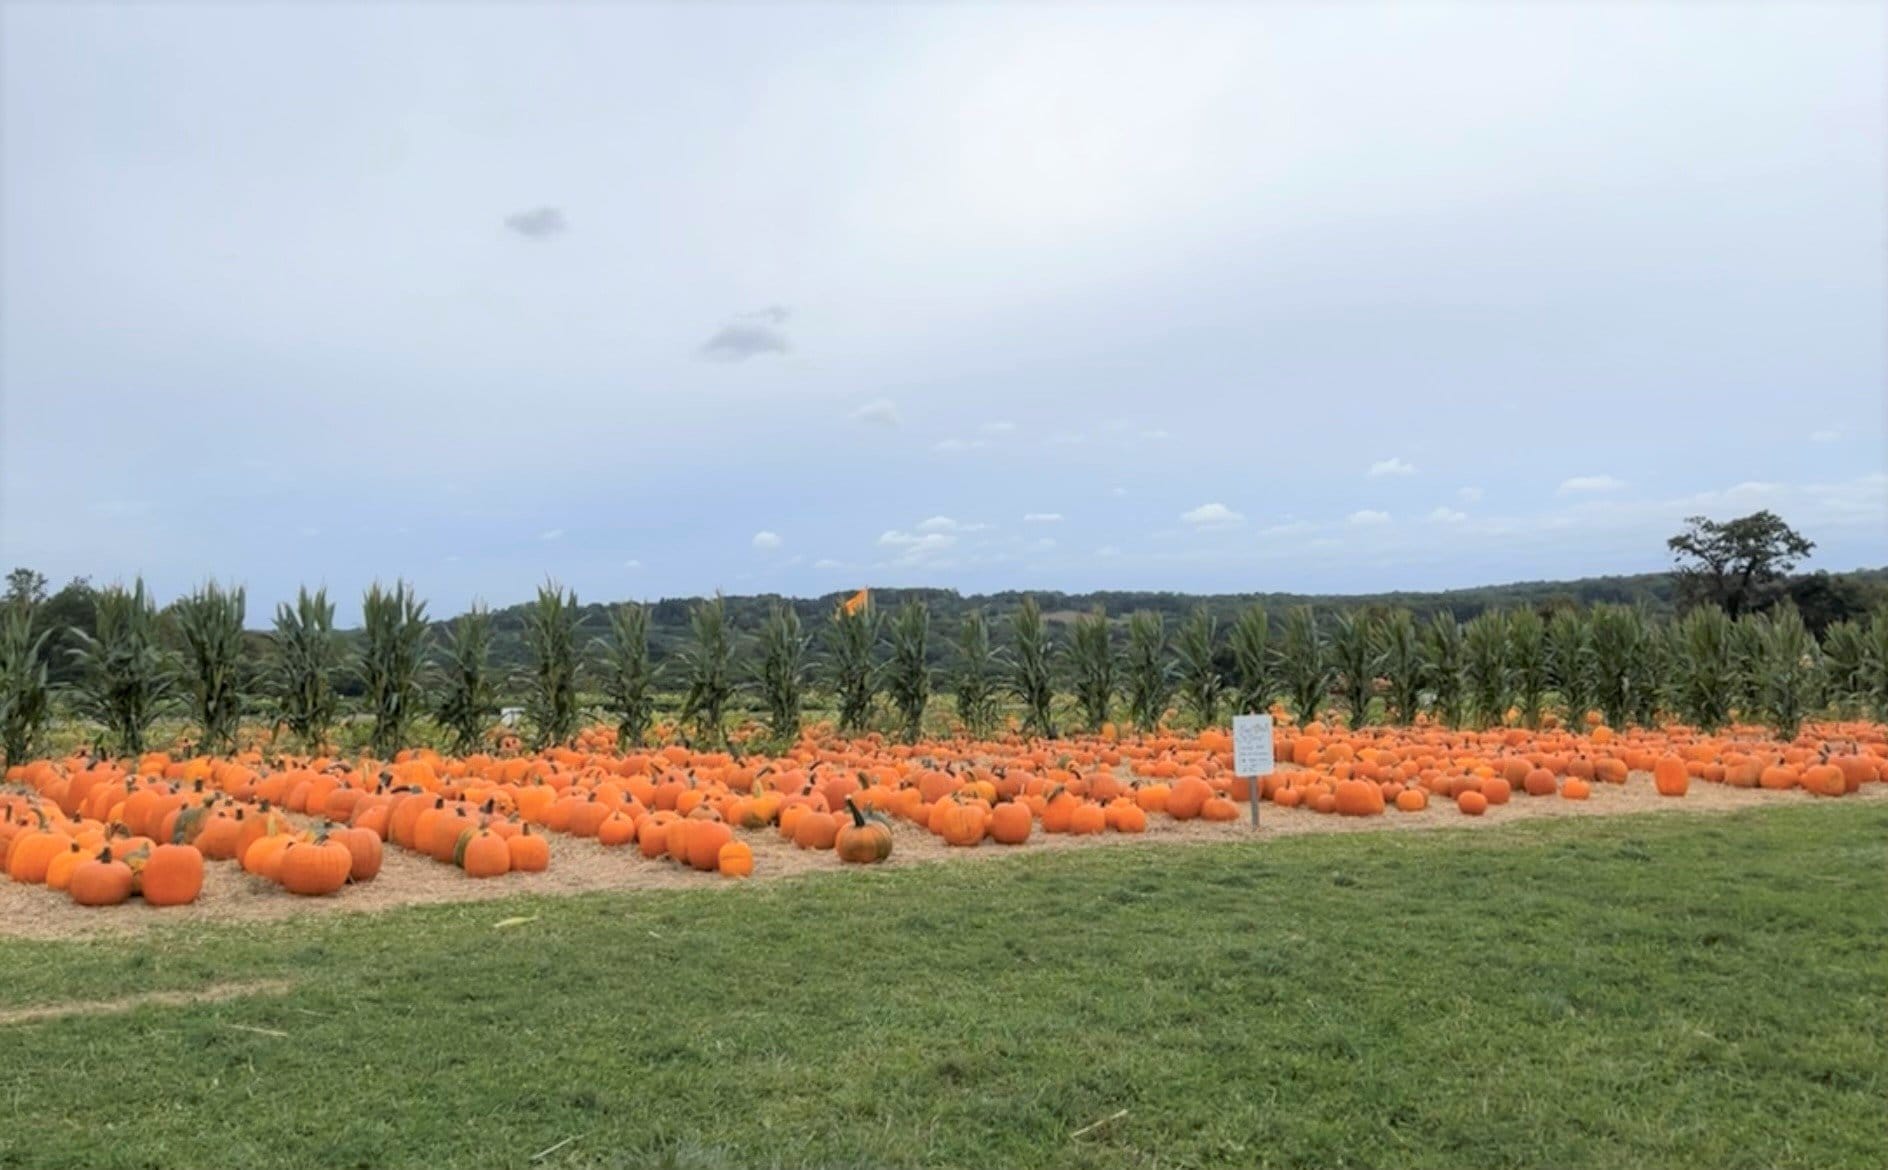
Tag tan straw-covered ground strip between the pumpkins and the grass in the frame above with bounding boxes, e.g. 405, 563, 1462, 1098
0, 774, 1888, 938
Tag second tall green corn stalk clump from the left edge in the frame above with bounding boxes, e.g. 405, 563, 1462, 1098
72, 577, 174, 755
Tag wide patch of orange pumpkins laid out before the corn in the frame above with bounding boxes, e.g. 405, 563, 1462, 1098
0, 723, 1888, 906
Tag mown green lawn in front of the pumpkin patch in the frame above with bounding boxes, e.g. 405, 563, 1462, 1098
0, 802, 1888, 1168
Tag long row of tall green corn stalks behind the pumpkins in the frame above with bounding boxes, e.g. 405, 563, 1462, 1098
0, 581, 1888, 759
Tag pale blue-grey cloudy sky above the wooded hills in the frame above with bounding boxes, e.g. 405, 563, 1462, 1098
0, 4, 1888, 623
